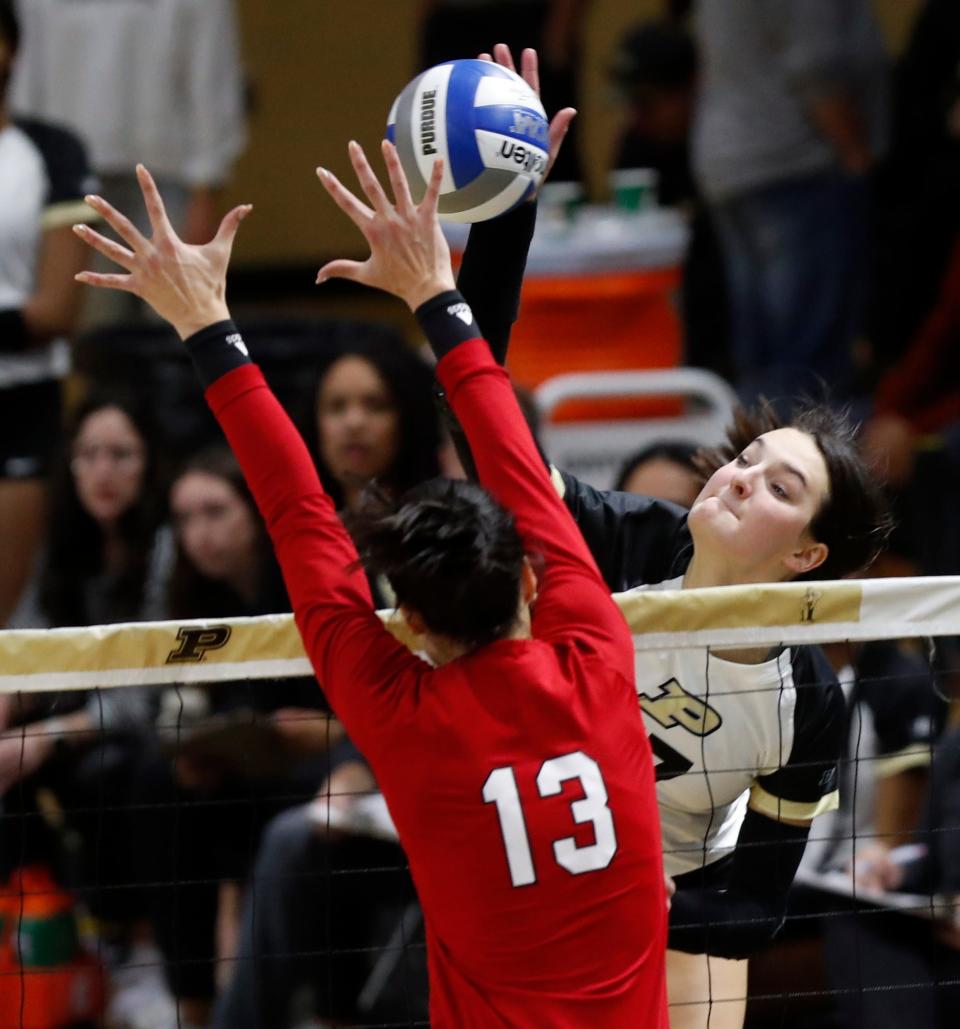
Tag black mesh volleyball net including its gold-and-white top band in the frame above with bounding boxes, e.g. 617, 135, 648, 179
0, 577, 960, 1029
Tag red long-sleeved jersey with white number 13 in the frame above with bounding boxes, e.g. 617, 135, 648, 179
207, 340, 668, 1029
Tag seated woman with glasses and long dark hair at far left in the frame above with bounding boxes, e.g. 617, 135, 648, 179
0, 391, 173, 946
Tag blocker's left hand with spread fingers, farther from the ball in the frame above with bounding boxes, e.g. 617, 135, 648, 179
73, 165, 252, 340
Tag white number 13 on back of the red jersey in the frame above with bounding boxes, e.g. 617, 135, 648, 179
484, 750, 616, 886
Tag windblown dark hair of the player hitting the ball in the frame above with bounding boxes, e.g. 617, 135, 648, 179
697, 400, 893, 579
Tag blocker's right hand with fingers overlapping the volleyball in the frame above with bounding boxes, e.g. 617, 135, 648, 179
317, 140, 454, 311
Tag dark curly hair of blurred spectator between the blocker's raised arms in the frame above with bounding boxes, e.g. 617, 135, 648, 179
306, 339, 440, 507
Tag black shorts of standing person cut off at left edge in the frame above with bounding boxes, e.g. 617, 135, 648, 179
0, 379, 61, 480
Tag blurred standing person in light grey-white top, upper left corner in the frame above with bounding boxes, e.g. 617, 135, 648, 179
10, 0, 245, 314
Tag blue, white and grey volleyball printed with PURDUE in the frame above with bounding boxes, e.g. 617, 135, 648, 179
387, 60, 549, 222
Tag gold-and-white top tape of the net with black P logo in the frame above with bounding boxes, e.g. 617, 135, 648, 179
0, 576, 960, 693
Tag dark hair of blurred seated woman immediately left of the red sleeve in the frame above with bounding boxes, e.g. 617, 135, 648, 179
170, 445, 289, 618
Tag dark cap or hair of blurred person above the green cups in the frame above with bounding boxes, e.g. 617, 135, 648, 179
609, 21, 698, 95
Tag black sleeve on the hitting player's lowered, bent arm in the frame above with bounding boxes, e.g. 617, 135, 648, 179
668, 811, 810, 958
